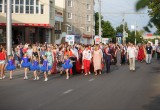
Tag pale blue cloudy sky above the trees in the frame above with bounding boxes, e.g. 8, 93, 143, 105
95, 0, 156, 32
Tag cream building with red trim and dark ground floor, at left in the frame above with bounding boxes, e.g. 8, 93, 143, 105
0, 0, 55, 44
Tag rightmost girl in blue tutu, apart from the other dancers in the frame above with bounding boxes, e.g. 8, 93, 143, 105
62, 56, 73, 79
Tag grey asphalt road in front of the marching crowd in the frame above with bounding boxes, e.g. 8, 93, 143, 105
0, 62, 160, 110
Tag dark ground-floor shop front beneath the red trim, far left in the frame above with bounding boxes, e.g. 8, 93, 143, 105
0, 24, 52, 45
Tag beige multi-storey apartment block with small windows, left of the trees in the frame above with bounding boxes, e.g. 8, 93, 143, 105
64, 0, 95, 44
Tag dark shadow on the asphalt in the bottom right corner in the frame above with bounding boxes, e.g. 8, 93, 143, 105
143, 96, 160, 110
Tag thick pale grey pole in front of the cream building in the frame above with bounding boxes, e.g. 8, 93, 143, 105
7, 0, 12, 55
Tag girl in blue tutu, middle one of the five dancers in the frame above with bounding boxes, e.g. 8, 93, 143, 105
30, 56, 40, 80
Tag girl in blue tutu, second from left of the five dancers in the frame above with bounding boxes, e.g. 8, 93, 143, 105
21, 53, 31, 80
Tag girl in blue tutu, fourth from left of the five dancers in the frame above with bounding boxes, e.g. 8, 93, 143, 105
41, 55, 52, 81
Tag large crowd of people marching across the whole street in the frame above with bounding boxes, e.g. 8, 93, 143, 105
0, 42, 160, 81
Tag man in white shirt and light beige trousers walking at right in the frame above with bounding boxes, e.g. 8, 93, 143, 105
127, 43, 136, 71
